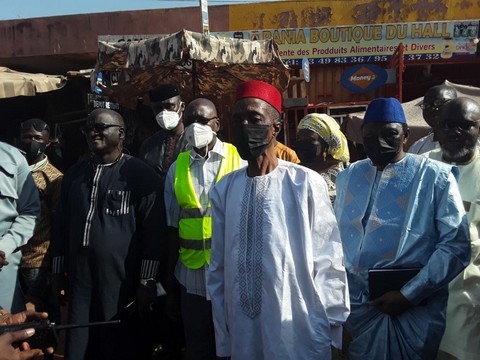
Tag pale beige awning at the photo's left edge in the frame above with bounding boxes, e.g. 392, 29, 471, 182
0, 66, 67, 99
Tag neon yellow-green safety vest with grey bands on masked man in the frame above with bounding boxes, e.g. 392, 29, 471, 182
174, 143, 241, 269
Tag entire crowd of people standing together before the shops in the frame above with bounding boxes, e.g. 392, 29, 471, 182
0, 80, 480, 360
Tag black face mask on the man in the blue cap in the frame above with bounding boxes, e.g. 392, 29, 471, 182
363, 136, 402, 166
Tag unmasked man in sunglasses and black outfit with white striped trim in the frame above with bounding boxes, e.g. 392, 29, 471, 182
52, 109, 165, 360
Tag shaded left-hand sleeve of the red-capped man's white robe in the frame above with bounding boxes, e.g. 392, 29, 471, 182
207, 187, 231, 357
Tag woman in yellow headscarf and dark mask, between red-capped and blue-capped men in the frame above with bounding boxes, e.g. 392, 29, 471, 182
295, 113, 350, 204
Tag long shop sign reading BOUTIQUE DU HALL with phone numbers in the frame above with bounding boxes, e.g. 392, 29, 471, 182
221, 20, 479, 65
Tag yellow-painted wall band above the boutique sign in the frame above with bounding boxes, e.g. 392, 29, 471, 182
229, 0, 480, 31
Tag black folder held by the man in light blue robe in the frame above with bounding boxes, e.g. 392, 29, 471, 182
368, 268, 421, 300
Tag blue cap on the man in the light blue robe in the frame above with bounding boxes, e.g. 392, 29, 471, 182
362, 98, 407, 125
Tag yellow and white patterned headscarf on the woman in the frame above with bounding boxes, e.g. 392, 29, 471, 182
297, 113, 350, 162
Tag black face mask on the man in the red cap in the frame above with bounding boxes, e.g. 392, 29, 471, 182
232, 124, 272, 161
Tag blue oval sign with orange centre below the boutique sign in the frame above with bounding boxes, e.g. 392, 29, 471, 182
342, 64, 388, 93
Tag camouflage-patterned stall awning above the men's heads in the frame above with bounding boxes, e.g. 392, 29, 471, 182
95, 30, 289, 107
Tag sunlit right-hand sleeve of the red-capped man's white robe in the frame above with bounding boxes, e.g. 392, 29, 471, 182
309, 178, 350, 349
